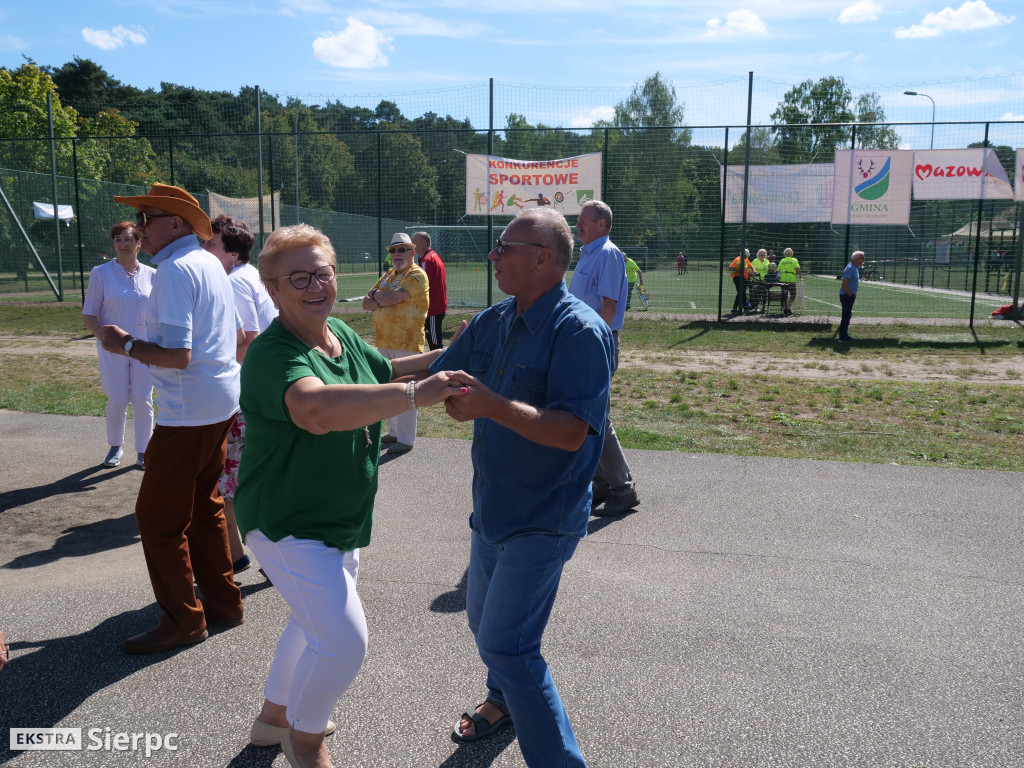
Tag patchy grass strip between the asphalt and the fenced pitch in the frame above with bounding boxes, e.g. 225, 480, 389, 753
0, 303, 1024, 471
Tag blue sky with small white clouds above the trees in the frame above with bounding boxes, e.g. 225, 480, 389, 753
0, 0, 1024, 131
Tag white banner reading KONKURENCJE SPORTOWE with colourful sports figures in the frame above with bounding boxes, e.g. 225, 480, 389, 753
466, 152, 601, 216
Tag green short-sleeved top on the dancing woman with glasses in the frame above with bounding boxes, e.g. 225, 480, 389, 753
234, 317, 391, 550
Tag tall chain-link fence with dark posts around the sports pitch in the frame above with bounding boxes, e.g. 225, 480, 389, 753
0, 121, 1024, 319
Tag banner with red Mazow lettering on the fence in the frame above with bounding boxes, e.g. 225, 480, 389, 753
913, 146, 1014, 200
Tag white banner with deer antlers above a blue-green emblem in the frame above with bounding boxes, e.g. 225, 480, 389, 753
831, 150, 913, 225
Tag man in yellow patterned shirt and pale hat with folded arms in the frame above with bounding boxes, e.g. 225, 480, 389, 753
362, 232, 430, 455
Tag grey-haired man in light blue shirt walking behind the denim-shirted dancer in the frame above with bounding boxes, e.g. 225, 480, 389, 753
569, 200, 640, 517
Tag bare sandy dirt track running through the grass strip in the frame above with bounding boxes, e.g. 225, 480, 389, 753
0, 336, 1024, 384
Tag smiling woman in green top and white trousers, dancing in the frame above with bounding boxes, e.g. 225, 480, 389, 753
236, 224, 465, 767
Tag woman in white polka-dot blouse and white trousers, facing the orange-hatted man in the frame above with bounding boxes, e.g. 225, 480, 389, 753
82, 221, 157, 469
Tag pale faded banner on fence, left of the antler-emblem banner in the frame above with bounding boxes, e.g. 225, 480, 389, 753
721, 163, 833, 224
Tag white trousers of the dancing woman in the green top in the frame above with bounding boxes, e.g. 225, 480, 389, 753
246, 530, 367, 733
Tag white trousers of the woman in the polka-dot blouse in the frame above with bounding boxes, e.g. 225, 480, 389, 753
96, 342, 153, 454
